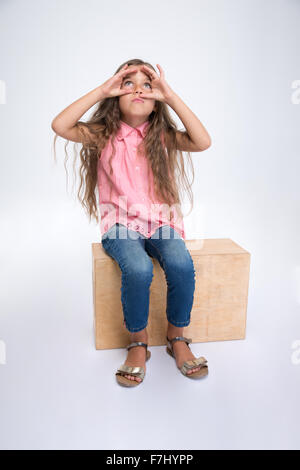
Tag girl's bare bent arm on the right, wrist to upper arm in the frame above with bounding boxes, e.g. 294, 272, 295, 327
165, 92, 211, 152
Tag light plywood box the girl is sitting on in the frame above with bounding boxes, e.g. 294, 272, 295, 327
92, 238, 250, 349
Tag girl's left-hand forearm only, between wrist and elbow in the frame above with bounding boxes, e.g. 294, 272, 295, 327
51, 86, 104, 130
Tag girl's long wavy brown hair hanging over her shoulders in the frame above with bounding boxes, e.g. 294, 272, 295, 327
54, 59, 194, 227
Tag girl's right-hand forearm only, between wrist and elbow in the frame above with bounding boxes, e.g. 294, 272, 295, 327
166, 92, 211, 148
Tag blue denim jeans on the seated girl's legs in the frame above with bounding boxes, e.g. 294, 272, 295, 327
102, 223, 195, 333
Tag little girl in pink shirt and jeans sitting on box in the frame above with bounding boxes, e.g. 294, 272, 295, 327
52, 59, 211, 386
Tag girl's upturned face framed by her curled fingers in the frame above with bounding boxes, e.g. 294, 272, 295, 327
119, 66, 155, 119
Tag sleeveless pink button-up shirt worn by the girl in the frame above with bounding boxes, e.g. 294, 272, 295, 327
97, 121, 185, 239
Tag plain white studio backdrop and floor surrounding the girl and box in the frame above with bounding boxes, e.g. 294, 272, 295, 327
0, 0, 300, 449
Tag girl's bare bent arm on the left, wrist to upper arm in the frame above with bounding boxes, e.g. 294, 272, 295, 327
51, 86, 105, 142
